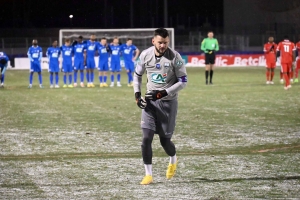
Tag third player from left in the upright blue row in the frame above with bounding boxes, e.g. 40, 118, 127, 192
60, 39, 74, 88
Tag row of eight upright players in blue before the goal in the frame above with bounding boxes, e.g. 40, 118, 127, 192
27, 35, 140, 88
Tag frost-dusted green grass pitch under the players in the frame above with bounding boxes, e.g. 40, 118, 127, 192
0, 67, 300, 199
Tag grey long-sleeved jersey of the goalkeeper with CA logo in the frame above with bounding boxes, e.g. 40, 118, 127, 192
133, 46, 187, 100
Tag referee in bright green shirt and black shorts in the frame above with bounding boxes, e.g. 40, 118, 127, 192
201, 31, 219, 85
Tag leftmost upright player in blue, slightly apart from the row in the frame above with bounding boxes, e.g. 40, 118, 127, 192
27, 39, 43, 88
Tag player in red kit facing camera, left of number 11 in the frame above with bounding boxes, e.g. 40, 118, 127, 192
264, 37, 277, 84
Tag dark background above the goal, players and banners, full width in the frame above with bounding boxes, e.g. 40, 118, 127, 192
0, 0, 300, 64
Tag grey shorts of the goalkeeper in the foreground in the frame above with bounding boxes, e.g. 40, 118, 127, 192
141, 99, 178, 138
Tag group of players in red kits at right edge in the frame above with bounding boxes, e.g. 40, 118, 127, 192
264, 36, 300, 90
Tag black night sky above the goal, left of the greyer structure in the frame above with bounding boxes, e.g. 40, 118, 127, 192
0, 0, 223, 28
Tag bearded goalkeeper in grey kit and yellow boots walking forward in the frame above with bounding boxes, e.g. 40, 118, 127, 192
133, 28, 187, 185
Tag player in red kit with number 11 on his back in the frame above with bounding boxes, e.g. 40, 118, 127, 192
277, 36, 296, 90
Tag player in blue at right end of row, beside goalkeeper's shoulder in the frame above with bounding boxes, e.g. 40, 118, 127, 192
122, 38, 140, 87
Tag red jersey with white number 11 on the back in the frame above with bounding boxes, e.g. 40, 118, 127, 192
277, 40, 296, 63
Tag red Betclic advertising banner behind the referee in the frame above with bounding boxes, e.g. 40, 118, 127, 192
186, 54, 279, 67
